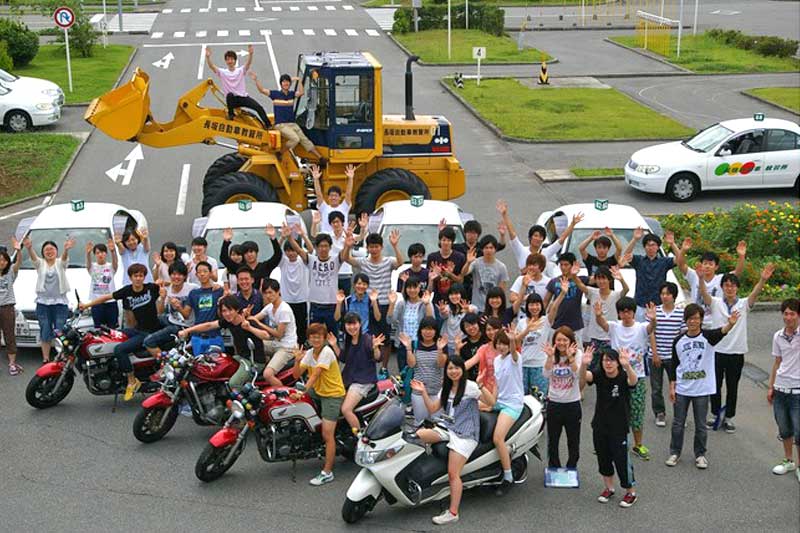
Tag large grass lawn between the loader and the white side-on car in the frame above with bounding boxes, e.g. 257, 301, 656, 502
459, 78, 694, 141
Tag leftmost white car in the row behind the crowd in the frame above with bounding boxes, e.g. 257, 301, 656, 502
14, 201, 147, 347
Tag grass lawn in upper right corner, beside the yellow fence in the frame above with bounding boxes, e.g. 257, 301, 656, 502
611, 34, 800, 73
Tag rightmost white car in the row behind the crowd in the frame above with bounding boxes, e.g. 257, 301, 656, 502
536, 201, 686, 304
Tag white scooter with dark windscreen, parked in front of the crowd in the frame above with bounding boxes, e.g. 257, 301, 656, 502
342, 396, 544, 524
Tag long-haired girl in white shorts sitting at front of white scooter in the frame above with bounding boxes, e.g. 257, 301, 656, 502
411, 356, 495, 525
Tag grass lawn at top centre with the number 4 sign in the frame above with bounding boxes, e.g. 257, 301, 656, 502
394, 30, 550, 65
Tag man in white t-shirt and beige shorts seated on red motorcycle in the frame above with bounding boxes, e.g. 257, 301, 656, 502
249, 278, 297, 387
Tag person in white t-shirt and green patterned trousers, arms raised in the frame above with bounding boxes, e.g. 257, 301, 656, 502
594, 296, 656, 461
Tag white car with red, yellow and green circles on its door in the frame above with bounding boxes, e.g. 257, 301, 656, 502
625, 113, 800, 202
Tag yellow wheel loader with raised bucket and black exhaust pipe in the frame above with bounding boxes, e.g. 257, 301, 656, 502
84, 52, 465, 216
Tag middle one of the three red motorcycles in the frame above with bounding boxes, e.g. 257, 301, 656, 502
133, 339, 297, 443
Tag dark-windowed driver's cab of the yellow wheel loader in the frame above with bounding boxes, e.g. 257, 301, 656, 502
295, 52, 382, 161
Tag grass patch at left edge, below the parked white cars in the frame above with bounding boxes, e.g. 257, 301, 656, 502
0, 133, 81, 204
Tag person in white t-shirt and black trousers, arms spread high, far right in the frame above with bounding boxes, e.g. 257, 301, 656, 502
697, 263, 775, 433
